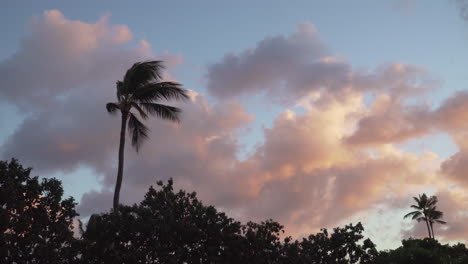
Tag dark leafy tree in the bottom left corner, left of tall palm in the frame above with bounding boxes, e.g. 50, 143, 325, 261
0, 159, 78, 263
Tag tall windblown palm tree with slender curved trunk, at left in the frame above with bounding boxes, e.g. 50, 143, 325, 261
106, 61, 188, 210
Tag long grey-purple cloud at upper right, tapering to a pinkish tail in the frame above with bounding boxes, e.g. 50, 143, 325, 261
206, 24, 437, 105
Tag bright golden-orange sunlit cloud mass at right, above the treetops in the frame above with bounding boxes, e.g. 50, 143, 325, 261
232, 100, 436, 234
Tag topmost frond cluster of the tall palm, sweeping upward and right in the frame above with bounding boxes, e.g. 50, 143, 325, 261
123, 61, 164, 93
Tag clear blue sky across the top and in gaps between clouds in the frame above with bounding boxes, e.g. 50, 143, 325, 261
0, 0, 468, 196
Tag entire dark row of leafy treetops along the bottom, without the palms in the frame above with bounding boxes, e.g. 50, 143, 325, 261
0, 160, 468, 264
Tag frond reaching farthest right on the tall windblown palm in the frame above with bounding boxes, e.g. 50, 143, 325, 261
132, 82, 189, 103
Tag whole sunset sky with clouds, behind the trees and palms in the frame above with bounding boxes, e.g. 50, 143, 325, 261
0, 0, 468, 249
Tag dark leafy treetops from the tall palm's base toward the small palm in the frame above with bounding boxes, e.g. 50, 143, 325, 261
82, 178, 377, 264
